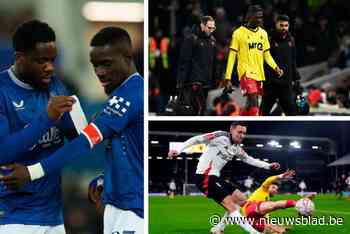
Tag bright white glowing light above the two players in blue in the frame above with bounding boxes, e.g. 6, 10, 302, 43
82, 1, 144, 22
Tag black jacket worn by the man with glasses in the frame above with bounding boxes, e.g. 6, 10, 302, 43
177, 26, 216, 88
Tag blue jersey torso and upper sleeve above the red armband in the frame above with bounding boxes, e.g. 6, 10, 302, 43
93, 74, 144, 217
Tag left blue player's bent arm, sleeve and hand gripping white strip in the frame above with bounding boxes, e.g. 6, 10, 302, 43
0, 96, 75, 164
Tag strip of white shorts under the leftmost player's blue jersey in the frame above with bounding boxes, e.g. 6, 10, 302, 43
0, 224, 66, 234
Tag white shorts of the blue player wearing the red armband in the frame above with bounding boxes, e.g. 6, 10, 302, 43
104, 205, 144, 234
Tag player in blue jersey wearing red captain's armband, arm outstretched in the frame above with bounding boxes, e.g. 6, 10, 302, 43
0, 27, 144, 234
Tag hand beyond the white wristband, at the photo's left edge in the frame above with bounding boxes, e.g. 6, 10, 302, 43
0, 163, 30, 190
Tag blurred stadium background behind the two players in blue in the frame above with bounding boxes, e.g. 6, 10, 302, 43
0, 0, 144, 234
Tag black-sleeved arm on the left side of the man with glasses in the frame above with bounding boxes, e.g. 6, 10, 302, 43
177, 36, 195, 87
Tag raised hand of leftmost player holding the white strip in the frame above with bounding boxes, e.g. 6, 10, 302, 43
47, 96, 76, 121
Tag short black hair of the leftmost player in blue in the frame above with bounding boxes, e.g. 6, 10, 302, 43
12, 20, 56, 52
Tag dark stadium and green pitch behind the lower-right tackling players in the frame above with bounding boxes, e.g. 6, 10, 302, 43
148, 121, 350, 234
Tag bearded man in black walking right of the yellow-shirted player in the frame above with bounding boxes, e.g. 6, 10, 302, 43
261, 15, 302, 115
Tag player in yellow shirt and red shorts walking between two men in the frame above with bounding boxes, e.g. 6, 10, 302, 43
224, 5, 283, 116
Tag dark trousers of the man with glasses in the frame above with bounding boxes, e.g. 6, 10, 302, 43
183, 83, 209, 115
